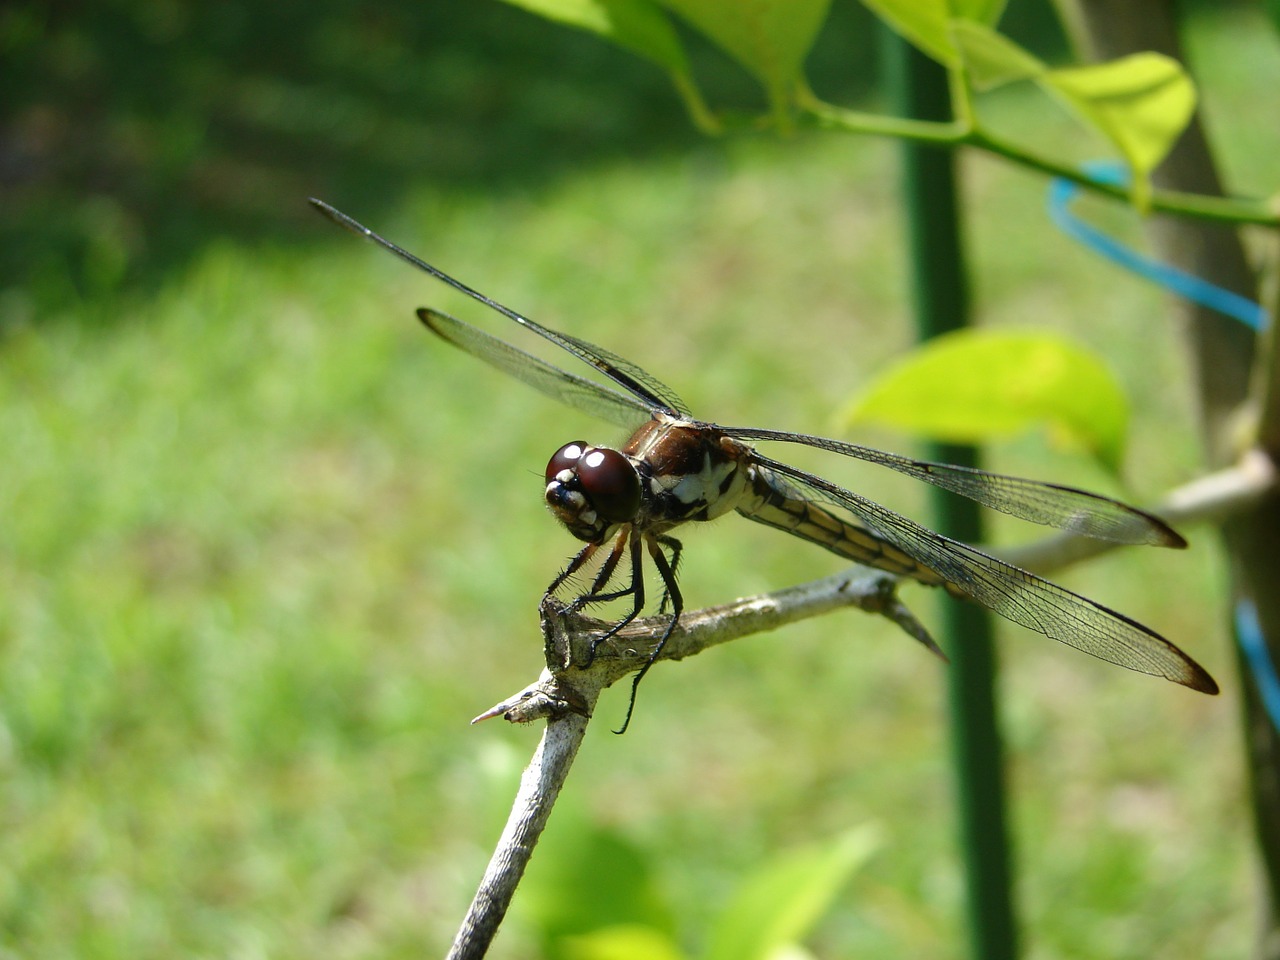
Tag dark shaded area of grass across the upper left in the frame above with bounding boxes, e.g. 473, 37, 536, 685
0, 0, 870, 315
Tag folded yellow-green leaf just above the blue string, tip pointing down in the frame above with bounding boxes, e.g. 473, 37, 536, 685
1039, 52, 1196, 209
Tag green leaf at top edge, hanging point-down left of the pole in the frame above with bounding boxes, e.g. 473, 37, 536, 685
662, 0, 831, 106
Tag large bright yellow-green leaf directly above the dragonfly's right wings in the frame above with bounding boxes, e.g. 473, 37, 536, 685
846, 330, 1129, 472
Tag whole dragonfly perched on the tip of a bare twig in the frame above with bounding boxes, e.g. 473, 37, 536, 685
311, 198, 1217, 732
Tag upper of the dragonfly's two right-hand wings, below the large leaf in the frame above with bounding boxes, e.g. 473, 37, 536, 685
721, 428, 1187, 547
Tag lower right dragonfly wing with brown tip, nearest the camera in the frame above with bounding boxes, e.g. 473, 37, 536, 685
754, 454, 1217, 694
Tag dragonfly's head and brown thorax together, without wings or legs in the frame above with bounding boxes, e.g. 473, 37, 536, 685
545, 417, 751, 543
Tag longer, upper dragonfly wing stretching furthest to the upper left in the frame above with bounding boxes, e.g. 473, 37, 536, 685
311, 197, 690, 420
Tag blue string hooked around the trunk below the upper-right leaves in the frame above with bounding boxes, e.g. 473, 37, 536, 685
1048, 160, 1267, 330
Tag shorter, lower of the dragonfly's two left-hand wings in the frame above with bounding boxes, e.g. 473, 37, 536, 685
417, 307, 652, 429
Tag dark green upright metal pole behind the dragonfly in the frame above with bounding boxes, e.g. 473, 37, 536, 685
884, 31, 1018, 960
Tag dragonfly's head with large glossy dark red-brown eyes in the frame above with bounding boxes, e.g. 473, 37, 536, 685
544, 440, 641, 543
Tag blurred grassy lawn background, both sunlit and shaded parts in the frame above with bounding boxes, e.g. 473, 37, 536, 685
0, 3, 1280, 957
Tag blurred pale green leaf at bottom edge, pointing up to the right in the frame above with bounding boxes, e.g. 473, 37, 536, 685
707, 826, 881, 960
